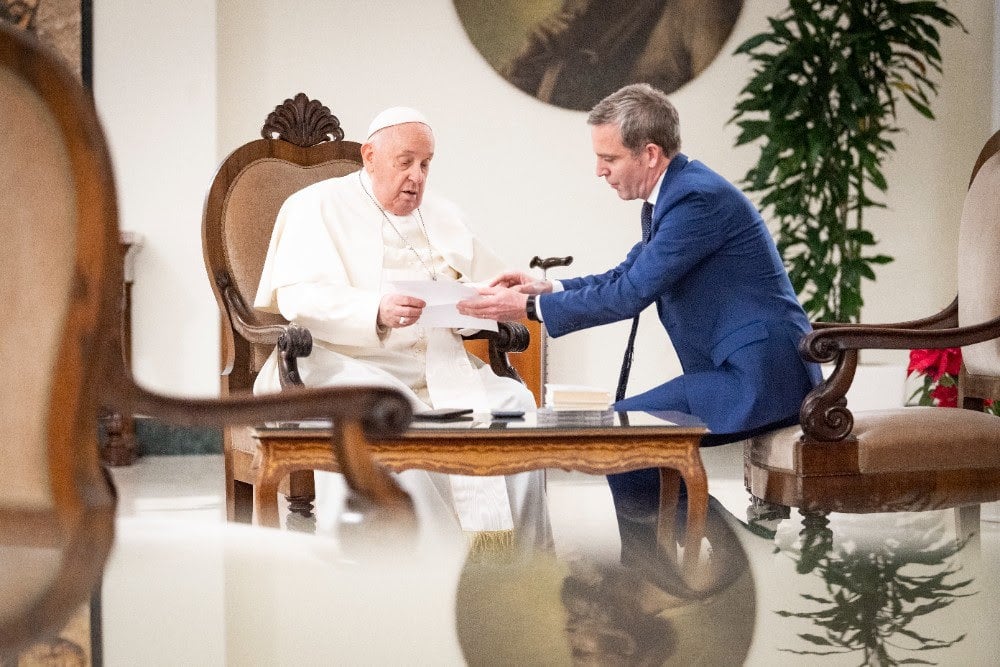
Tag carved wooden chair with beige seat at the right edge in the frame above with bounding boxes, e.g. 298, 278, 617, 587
745, 133, 1000, 513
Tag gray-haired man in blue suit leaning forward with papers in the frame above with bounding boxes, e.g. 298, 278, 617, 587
459, 84, 821, 564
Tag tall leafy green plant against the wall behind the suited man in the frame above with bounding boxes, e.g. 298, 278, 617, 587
729, 0, 965, 322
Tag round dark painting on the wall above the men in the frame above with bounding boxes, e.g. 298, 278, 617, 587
454, 0, 743, 111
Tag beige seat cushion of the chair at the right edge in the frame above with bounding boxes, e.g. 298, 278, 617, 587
751, 407, 1000, 473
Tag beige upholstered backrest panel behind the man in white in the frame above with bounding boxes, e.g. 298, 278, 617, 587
222, 158, 360, 371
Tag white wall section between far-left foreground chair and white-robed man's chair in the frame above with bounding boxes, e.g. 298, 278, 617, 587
94, 0, 219, 395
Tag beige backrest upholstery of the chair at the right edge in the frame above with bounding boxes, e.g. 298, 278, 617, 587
958, 154, 1000, 376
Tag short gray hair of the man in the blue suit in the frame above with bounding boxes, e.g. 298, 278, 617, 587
587, 83, 681, 158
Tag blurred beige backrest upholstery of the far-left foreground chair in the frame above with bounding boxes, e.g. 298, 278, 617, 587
0, 69, 73, 509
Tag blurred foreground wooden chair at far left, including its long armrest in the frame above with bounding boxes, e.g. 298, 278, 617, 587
0, 25, 412, 664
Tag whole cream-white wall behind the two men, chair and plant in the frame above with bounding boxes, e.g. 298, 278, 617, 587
95, 0, 994, 400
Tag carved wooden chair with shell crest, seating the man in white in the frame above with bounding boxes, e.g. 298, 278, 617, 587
202, 93, 529, 526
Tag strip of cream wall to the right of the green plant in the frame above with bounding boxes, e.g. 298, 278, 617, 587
862, 0, 994, 363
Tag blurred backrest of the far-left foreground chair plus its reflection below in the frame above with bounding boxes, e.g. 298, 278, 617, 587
0, 24, 120, 664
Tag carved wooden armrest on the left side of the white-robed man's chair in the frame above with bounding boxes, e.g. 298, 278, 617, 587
218, 275, 312, 389
